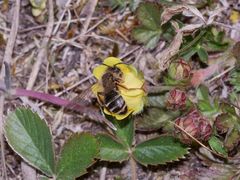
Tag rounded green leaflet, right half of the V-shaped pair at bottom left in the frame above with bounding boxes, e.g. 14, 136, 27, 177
57, 133, 99, 180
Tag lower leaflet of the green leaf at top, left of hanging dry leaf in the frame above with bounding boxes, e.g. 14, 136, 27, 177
132, 26, 162, 49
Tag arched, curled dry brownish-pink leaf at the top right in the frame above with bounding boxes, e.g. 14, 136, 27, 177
161, 5, 206, 24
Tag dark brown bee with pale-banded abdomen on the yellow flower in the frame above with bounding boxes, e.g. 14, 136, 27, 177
97, 64, 128, 115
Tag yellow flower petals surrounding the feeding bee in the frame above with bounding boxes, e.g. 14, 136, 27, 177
92, 57, 147, 120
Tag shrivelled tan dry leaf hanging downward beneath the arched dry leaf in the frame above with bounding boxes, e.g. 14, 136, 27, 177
156, 31, 183, 71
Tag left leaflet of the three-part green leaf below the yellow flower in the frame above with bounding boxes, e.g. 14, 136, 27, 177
97, 134, 129, 162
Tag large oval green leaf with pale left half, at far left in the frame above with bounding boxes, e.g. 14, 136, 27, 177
4, 108, 54, 176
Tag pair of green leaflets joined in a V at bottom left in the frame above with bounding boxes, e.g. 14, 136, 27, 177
4, 108, 99, 180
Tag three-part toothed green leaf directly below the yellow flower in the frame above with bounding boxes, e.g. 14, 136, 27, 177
97, 116, 188, 166
